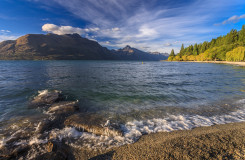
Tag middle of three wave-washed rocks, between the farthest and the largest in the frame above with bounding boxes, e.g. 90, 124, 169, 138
48, 101, 79, 114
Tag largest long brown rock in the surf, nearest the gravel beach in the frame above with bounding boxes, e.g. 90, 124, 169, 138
64, 113, 123, 137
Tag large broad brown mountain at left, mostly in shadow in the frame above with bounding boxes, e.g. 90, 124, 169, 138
0, 34, 110, 60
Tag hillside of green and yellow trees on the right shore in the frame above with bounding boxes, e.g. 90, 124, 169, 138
168, 25, 245, 61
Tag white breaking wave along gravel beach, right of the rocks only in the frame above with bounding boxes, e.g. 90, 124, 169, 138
124, 109, 245, 137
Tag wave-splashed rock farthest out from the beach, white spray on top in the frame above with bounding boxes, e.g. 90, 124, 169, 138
31, 90, 61, 106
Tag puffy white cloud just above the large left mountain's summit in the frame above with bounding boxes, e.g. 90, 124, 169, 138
42, 24, 83, 35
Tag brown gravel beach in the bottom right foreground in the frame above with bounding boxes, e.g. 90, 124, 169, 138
83, 122, 245, 159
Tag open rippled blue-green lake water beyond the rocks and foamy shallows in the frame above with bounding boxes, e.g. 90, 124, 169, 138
0, 61, 245, 121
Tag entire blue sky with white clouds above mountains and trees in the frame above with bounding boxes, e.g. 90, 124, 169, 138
0, 0, 245, 53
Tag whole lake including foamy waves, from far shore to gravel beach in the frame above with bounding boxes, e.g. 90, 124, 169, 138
0, 61, 245, 156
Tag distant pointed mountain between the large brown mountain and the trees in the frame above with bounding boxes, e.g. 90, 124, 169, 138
112, 45, 168, 61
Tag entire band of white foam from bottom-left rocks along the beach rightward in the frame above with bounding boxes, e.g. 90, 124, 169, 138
0, 100, 245, 149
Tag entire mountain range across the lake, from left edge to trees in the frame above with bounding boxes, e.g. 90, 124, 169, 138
0, 34, 167, 60
